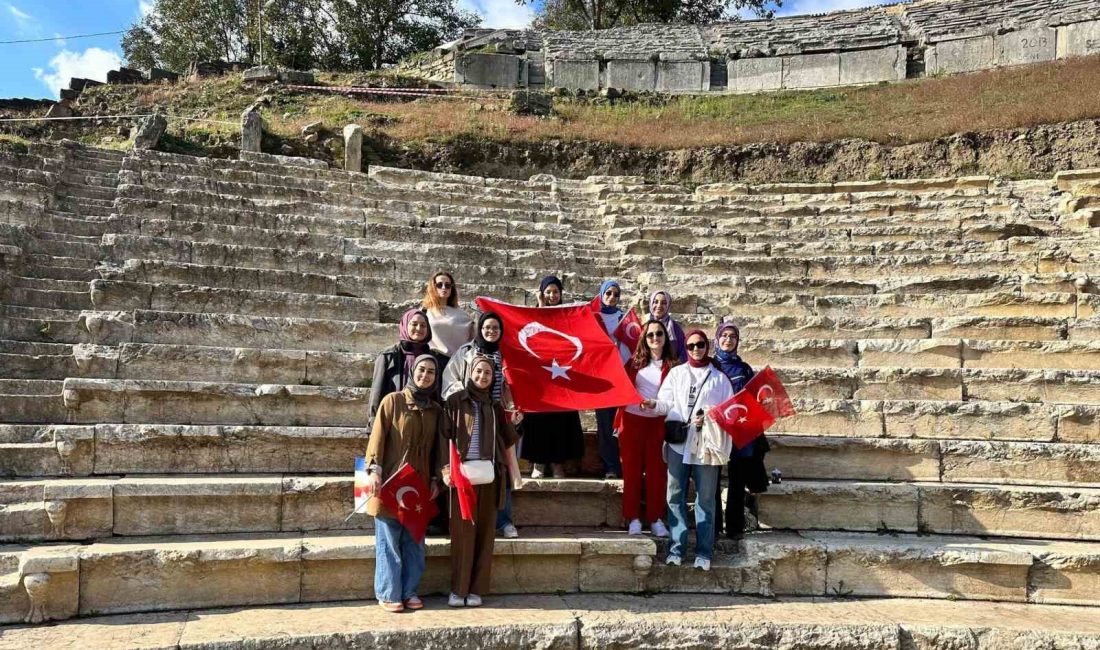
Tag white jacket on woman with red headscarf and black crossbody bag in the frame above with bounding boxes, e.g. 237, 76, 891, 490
657, 363, 734, 465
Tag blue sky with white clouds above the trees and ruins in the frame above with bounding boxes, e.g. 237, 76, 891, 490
0, 0, 898, 99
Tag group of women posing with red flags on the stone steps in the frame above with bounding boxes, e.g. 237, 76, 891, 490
366, 273, 767, 612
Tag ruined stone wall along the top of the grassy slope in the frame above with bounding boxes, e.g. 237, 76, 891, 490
414, 0, 1100, 92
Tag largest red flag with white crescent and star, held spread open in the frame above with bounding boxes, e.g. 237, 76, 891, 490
477, 298, 641, 412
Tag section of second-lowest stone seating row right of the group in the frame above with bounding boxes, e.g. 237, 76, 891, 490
758, 480, 1100, 538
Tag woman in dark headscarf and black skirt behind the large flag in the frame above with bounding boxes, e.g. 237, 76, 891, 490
521, 275, 584, 478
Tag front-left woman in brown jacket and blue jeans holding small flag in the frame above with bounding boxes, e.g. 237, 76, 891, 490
366, 354, 446, 613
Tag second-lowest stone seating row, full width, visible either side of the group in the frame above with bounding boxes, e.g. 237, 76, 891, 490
0, 472, 1100, 542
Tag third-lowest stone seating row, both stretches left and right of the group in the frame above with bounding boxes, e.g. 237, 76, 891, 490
0, 422, 1100, 494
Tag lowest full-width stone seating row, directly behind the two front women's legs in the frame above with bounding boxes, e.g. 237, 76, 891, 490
0, 529, 1097, 623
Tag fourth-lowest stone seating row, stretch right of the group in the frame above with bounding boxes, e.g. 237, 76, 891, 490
772, 397, 1100, 443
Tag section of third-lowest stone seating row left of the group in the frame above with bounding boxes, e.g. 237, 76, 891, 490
0, 425, 370, 476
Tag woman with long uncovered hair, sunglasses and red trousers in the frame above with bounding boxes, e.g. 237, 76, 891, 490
618, 320, 678, 537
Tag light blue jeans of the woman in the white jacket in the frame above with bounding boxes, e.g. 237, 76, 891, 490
664, 445, 721, 560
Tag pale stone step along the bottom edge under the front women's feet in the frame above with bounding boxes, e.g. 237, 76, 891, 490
8, 594, 1100, 650
